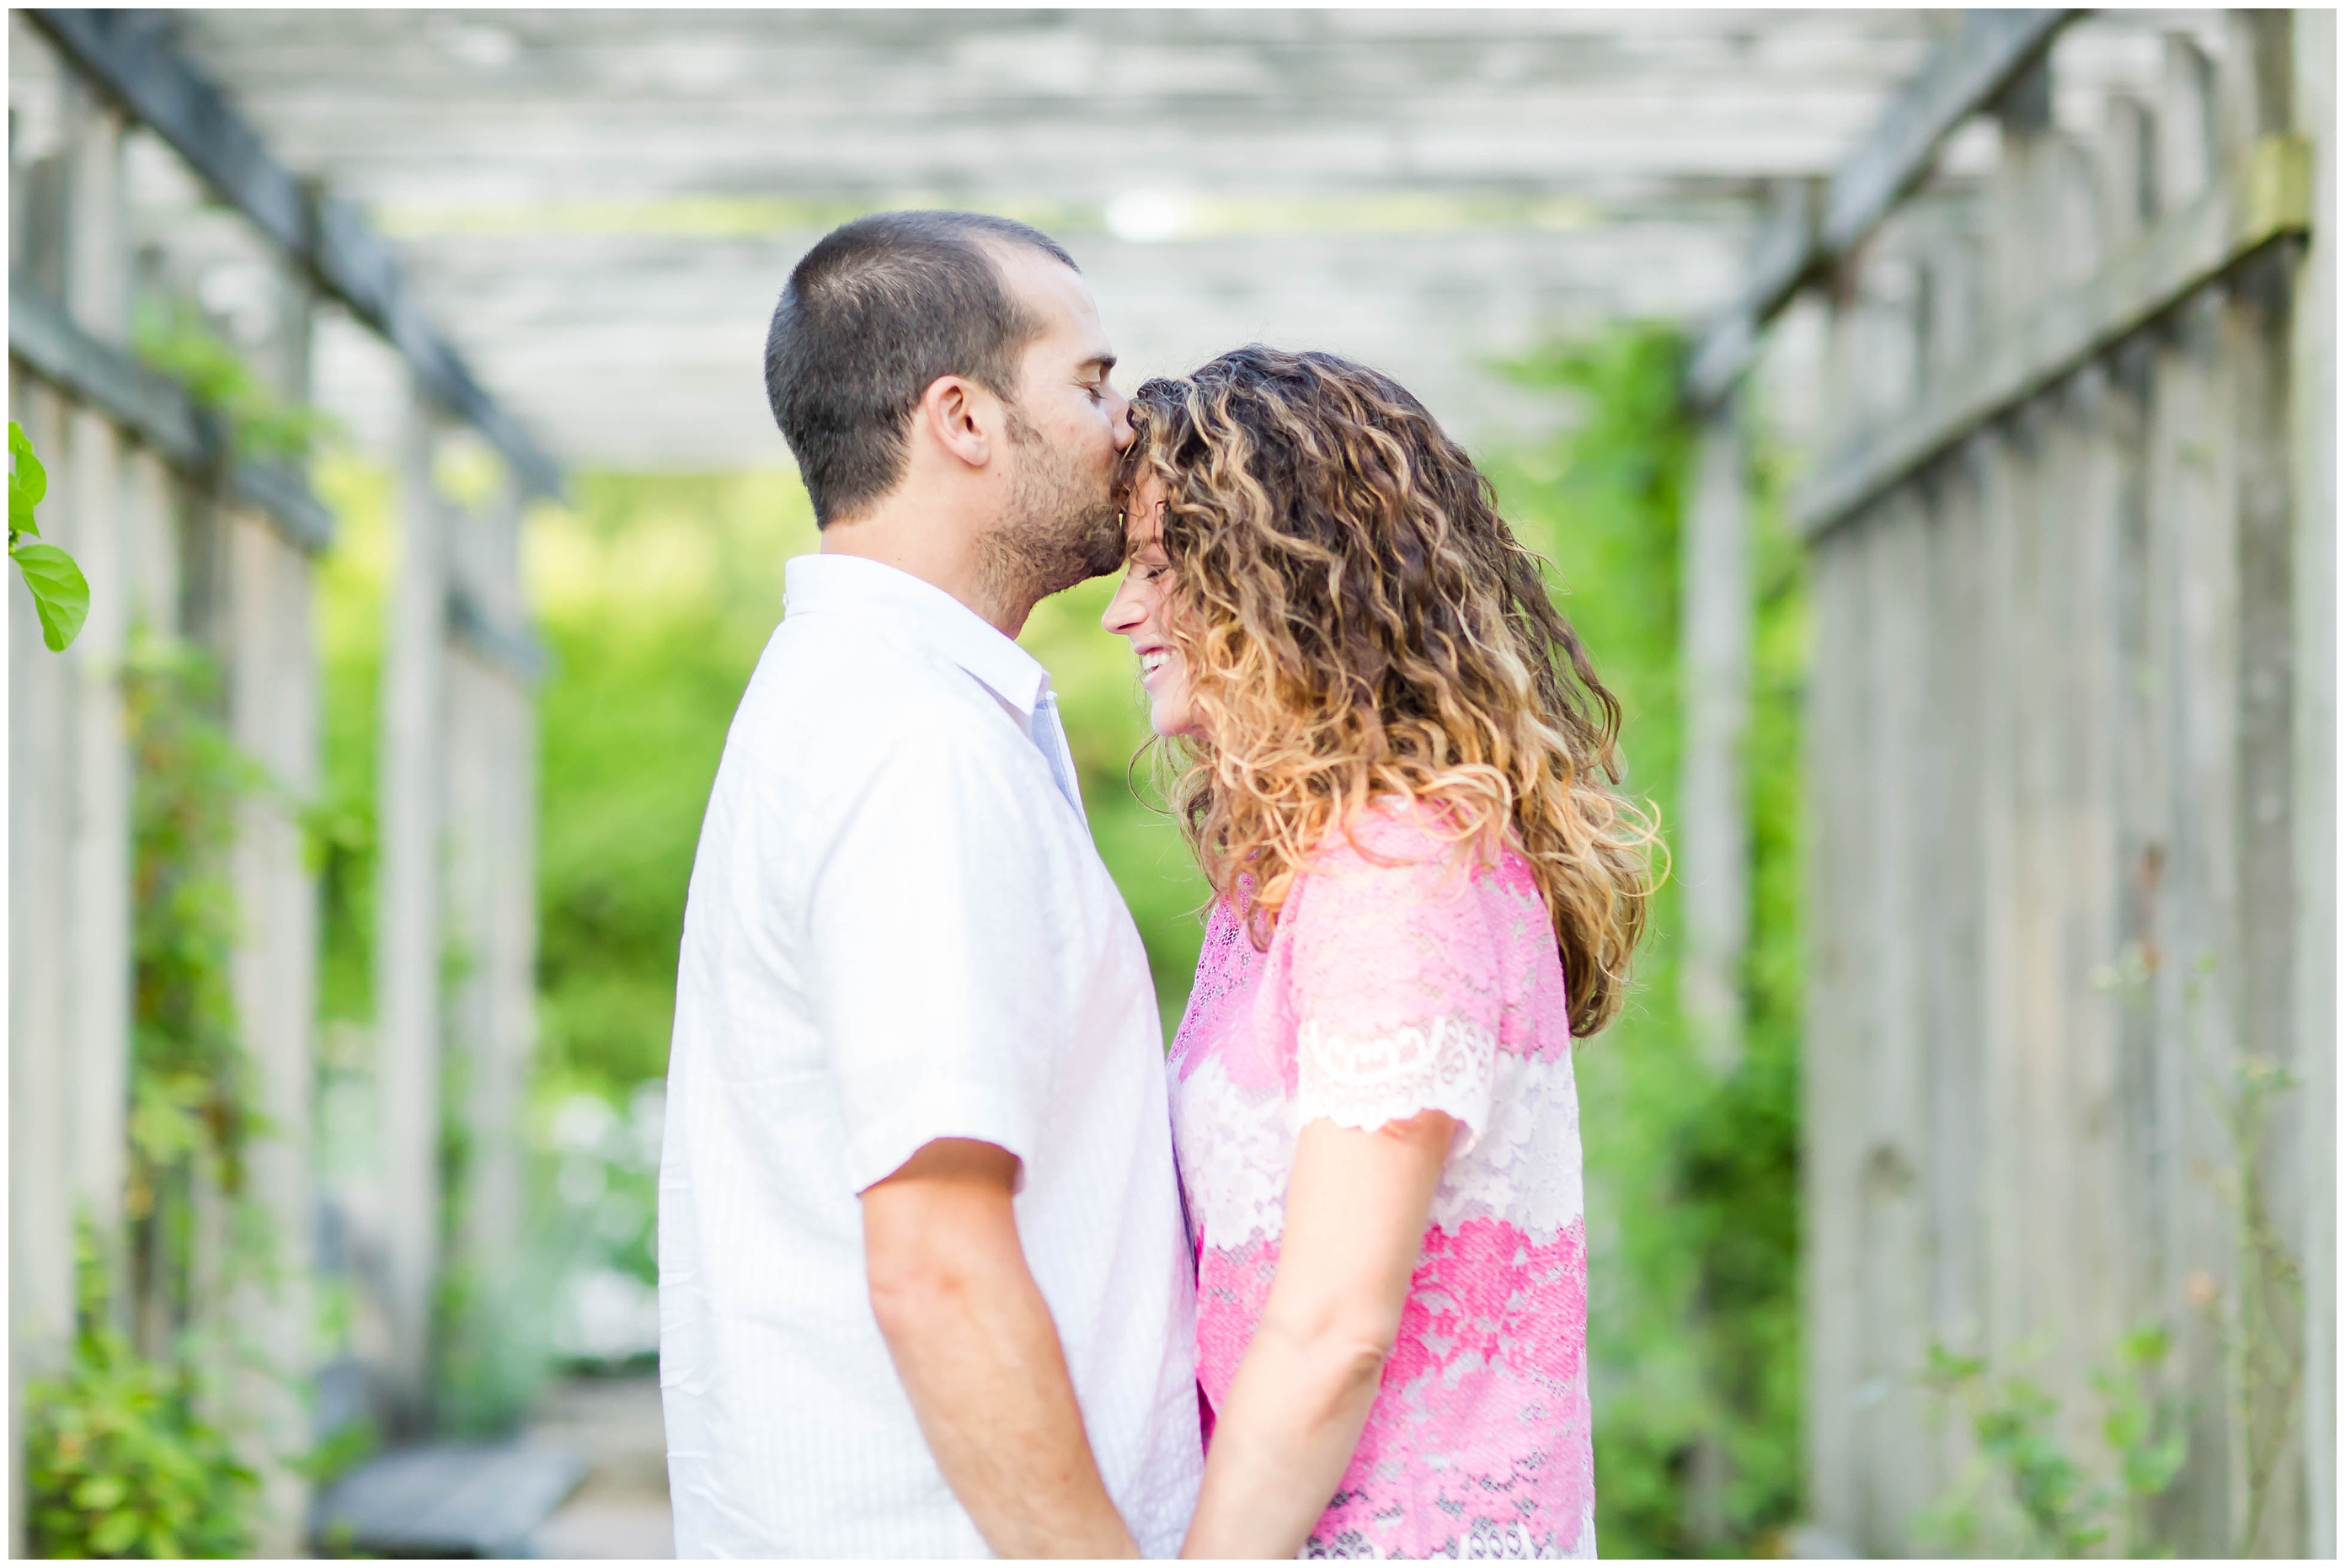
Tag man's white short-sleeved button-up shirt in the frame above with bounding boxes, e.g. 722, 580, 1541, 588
659, 556, 1203, 1556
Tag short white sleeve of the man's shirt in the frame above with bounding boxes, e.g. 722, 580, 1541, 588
807, 733, 1071, 1193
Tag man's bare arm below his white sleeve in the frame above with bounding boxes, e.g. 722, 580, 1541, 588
863, 1139, 1140, 1556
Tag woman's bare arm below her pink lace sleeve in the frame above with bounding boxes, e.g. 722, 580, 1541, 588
1182, 1111, 1456, 1556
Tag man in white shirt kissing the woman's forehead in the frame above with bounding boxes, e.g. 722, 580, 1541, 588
659, 213, 1200, 1556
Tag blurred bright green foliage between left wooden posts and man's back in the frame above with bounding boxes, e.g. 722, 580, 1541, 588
530, 473, 816, 1099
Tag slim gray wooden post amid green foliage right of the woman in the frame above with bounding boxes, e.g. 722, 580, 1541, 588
1677, 392, 1752, 1074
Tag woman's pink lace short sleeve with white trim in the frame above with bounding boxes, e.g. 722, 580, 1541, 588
1280, 832, 1504, 1151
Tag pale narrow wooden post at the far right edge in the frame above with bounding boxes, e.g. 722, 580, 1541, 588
2289, 9, 2338, 1559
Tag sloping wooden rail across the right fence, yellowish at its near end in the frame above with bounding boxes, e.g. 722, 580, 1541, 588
1792, 136, 2312, 539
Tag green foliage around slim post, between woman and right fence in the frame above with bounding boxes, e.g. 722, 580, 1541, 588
1482, 326, 1806, 1556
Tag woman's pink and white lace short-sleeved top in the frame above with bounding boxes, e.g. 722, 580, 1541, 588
1170, 808, 1597, 1556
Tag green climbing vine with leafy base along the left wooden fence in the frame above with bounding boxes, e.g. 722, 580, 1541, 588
26, 635, 277, 1556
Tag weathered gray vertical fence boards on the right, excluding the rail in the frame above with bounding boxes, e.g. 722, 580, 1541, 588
1806, 14, 2336, 1554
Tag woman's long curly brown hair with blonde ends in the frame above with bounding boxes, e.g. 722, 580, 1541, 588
1124, 344, 1656, 1036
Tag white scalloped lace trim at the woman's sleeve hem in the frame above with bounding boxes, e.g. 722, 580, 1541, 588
1295, 1017, 1498, 1158
